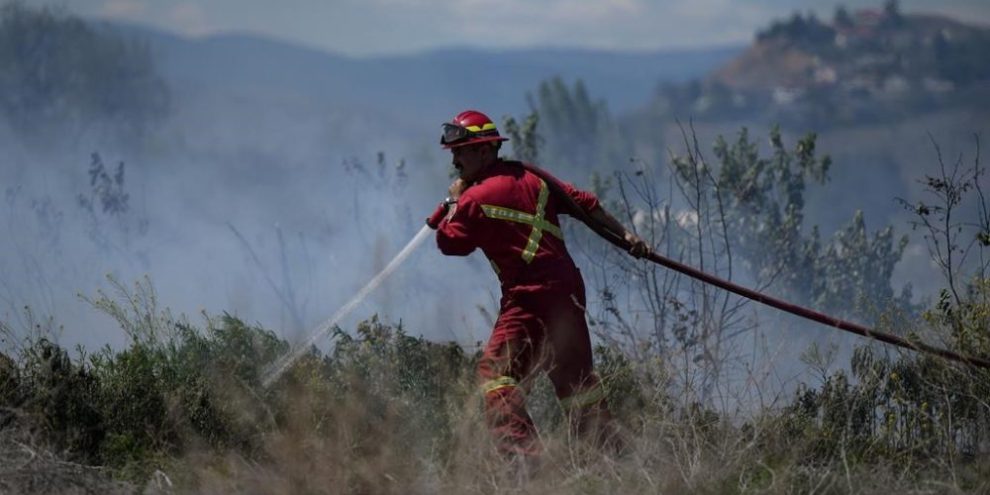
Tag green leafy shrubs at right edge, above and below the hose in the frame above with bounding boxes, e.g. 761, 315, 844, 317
782, 137, 990, 490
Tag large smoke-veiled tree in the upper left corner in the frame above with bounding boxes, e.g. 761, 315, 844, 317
0, 1, 168, 141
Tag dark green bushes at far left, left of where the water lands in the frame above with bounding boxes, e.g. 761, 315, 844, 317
2, 276, 287, 480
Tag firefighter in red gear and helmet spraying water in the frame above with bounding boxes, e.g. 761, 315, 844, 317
427, 110, 649, 456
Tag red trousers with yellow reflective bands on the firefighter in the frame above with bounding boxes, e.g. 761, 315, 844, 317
478, 269, 608, 454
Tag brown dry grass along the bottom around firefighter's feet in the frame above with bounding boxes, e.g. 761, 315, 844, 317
143, 362, 990, 495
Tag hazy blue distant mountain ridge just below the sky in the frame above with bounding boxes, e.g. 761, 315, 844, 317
104, 23, 743, 115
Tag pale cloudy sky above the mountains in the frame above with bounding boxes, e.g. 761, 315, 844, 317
44, 0, 990, 56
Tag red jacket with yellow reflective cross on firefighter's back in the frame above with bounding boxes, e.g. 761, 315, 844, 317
437, 159, 598, 290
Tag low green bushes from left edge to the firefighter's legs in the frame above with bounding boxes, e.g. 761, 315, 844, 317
0, 282, 475, 481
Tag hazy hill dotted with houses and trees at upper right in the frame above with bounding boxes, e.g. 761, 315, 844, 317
654, 2, 990, 129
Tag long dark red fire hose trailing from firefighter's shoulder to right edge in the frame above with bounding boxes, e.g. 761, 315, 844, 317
523, 164, 990, 368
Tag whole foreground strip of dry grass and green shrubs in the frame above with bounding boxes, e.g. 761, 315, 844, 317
0, 286, 990, 495
